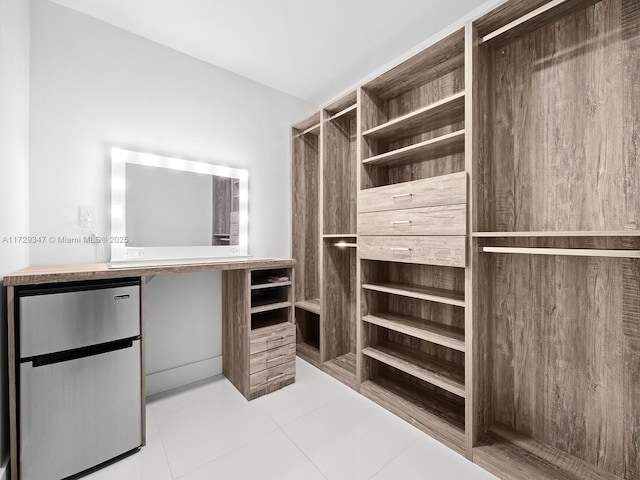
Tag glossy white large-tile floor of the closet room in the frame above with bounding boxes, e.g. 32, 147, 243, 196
84, 359, 496, 480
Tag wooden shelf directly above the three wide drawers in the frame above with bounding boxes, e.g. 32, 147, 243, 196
362, 130, 464, 166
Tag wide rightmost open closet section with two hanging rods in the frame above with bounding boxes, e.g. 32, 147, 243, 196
472, 0, 640, 480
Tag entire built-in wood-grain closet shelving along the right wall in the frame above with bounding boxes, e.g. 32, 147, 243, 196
292, 0, 640, 480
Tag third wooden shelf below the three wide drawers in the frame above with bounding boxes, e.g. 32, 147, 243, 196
362, 343, 465, 398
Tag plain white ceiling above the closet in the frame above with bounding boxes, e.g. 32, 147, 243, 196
51, 0, 485, 104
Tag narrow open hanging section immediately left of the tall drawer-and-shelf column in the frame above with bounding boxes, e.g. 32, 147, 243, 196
321, 91, 358, 388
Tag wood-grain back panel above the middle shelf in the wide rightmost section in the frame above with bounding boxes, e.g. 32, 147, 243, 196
489, 0, 640, 231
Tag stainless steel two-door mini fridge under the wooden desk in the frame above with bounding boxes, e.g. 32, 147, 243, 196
18, 279, 142, 480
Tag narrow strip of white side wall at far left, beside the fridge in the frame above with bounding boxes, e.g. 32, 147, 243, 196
0, 0, 29, 468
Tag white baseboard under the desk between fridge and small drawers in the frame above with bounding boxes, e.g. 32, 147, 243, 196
145, 355, 222, 396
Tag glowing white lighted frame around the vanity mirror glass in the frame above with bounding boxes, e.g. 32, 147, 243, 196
109, 148, 249, 267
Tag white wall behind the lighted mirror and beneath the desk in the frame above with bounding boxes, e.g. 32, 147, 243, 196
29, 0, 313, 391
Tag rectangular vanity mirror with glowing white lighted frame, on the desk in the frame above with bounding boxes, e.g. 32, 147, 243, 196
110, 148, 249, 267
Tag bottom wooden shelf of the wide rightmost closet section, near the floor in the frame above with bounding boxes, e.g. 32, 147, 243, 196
473, 424, 619, 480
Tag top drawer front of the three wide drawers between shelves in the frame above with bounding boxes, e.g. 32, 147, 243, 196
358, 172, 467, 213
